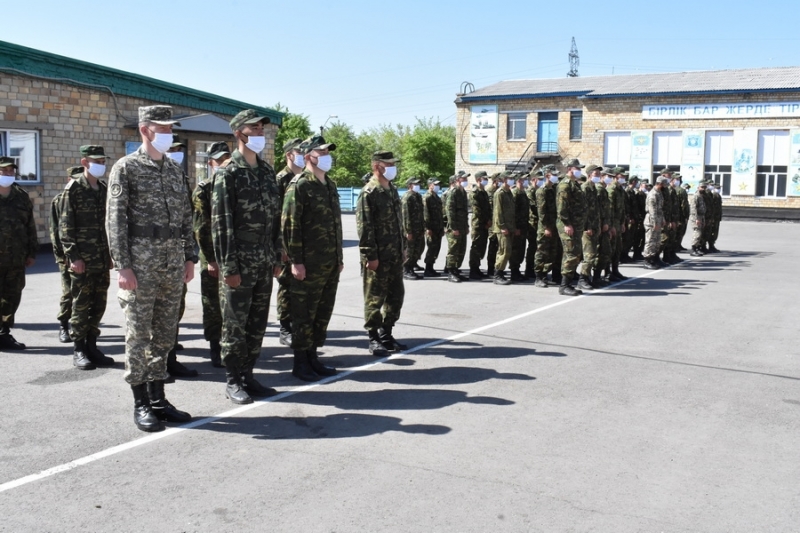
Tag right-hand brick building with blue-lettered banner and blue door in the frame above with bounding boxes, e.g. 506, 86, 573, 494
456, 67, 800, 215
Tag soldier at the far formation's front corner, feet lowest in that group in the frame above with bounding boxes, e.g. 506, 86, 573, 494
556, 159, 584, 296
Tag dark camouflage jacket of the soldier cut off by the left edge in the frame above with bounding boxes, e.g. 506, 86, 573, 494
0, 183, 39, 268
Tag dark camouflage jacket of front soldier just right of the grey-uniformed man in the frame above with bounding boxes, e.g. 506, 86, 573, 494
211, 150, 283, 277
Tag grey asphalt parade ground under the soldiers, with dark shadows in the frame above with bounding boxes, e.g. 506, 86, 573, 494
0, 214, 800, 533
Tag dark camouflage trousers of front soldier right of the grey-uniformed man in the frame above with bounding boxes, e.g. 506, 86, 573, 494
219, 261, 272, 371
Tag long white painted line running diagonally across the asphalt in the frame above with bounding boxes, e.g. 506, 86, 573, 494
0, 264, 664, 492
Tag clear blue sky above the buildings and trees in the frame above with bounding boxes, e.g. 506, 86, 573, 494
0, 0, 800, 131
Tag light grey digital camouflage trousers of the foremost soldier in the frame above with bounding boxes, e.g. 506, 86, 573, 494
117, 263, 186, 385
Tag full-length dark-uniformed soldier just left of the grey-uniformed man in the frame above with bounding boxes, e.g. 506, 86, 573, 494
58, 145, 114, 370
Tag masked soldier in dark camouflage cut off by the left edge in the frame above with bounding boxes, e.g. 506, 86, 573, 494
0, 157, 39, 351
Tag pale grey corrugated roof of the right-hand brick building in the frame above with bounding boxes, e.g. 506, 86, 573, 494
456, 67, 800, 102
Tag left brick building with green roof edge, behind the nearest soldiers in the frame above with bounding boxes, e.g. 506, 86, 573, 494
0, 41, 283, 243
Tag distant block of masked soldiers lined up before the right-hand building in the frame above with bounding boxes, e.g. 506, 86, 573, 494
402, 163, 722, 295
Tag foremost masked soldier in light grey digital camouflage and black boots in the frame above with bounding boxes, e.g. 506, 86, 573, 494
106, 105, 197, 431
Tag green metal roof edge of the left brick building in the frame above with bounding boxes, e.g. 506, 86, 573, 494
0, 41, 283, 125
